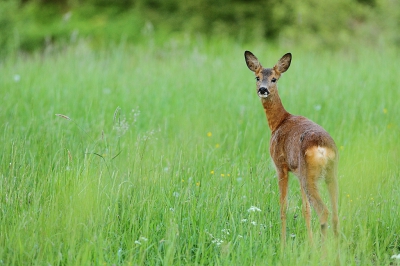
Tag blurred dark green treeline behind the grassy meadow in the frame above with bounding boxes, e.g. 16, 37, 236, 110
0, 0, 400, 53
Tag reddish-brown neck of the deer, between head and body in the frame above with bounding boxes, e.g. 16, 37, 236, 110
261, 93, 290, 132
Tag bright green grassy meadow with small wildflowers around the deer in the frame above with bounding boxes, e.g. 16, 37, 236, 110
0, 37, 400, 265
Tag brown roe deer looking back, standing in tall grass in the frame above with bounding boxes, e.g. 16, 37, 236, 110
244, 51, 339, 245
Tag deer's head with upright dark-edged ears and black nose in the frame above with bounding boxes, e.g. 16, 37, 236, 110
244, 51, 292, 98
